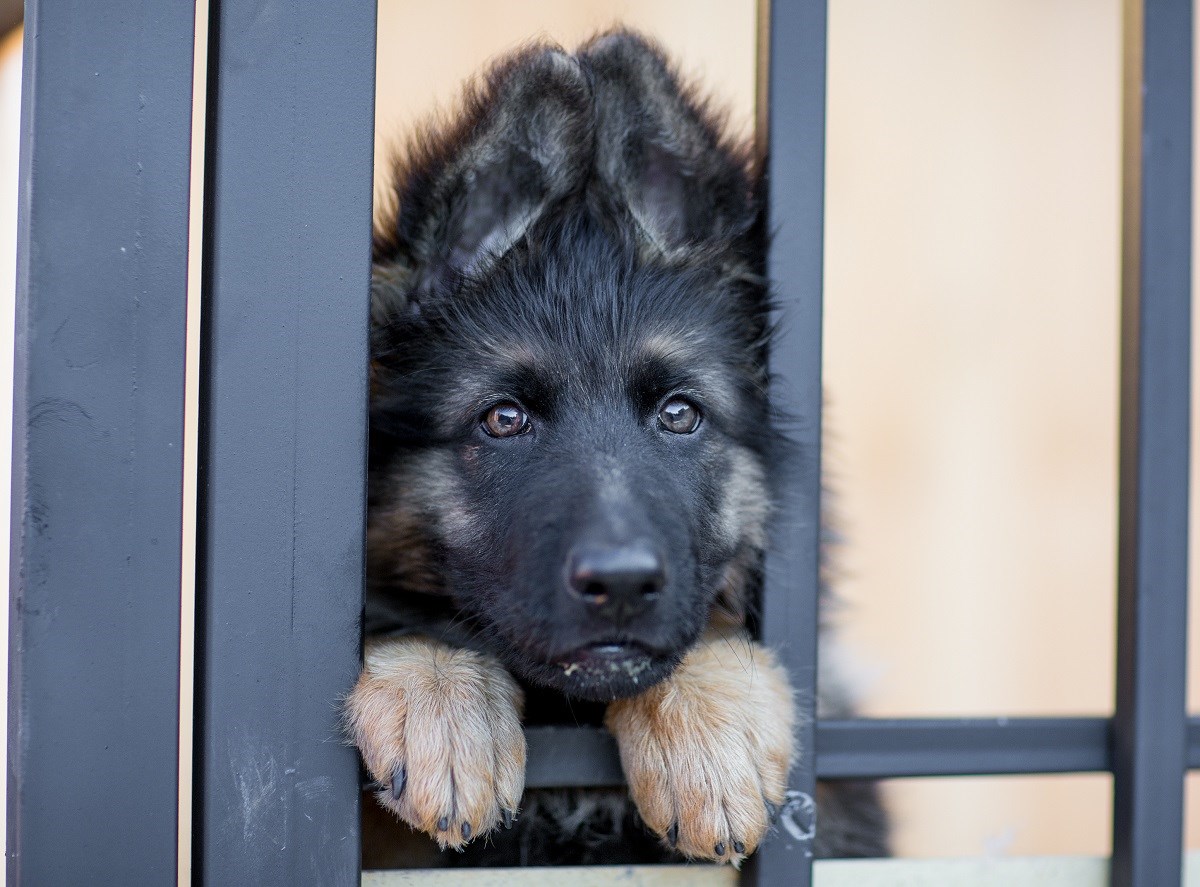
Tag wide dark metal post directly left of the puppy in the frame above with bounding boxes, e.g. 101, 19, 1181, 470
193, 0, 376, 887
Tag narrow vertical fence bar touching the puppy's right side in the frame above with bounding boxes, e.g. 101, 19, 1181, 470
744, 0, 827, 887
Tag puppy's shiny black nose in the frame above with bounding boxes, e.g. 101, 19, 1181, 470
570, 546, 667, 623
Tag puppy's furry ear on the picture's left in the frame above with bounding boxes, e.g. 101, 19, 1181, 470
371, 47, 593, 323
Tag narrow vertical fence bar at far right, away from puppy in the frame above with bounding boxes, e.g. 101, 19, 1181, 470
1112, 0, 1193, 887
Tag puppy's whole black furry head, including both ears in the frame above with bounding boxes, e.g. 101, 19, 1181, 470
368, 34, 773, 700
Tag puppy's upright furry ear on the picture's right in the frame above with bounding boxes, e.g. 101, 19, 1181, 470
580, 31, 754, 253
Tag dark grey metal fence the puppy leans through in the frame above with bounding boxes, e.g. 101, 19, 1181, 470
7, 0, 1200, 887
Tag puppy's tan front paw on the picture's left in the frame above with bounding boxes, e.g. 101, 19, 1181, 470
346, 637, 526, 849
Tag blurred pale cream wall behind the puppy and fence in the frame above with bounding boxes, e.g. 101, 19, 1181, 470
0, 0, 1200, 856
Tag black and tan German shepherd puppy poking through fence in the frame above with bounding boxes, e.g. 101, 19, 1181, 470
347, 31, 886, 865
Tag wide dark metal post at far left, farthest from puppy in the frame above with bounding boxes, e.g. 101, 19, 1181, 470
7, 0, 194, 885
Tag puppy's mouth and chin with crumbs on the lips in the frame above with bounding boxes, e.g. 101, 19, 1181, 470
510, 645, 683, 702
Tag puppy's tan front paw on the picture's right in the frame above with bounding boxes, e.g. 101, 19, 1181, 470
606, 636, 794, 864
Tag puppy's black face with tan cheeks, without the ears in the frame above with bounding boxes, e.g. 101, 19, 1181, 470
374, 218, 767, 699
